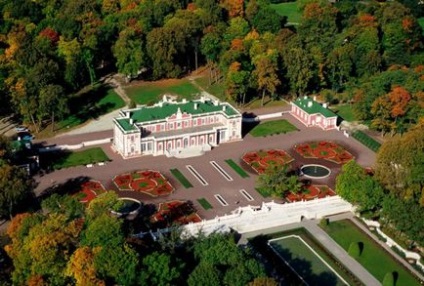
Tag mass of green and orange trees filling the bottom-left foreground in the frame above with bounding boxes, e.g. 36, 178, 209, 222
1, 192, 276, 286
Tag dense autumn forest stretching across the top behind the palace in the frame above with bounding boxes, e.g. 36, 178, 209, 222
0, 0, 424, 134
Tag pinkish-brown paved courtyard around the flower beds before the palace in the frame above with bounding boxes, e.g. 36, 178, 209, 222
36, 114, 375, 219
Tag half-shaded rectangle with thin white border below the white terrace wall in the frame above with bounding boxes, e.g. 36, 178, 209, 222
270, 235, 346, 286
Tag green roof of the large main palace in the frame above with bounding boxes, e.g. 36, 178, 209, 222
116, 100, 240, 131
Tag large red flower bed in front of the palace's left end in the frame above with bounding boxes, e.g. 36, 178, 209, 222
113, 170, 174, 197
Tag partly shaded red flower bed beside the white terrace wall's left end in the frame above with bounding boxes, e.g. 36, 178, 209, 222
150, 200, 202, 226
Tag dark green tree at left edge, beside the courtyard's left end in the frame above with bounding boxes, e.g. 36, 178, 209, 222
0, 164, 34, 218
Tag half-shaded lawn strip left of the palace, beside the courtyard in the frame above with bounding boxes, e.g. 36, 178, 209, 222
41, 147, 109, 169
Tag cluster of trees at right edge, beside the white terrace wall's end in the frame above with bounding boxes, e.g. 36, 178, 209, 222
336, 122, 424, 245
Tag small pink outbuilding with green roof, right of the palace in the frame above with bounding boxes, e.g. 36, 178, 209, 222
290, 96, 337, 130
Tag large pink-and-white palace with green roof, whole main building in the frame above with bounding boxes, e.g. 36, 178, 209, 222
112, 96, 242, 158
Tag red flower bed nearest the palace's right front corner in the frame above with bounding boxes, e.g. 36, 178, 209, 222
242, 149, 293, 174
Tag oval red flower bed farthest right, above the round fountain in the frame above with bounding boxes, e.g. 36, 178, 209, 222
294, 141, 354, 164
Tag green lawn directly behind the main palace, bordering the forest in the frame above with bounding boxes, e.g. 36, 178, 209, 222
125, 79, 200, 105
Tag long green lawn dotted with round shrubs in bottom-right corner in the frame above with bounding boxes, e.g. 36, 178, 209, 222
324, 220, 419, 285
